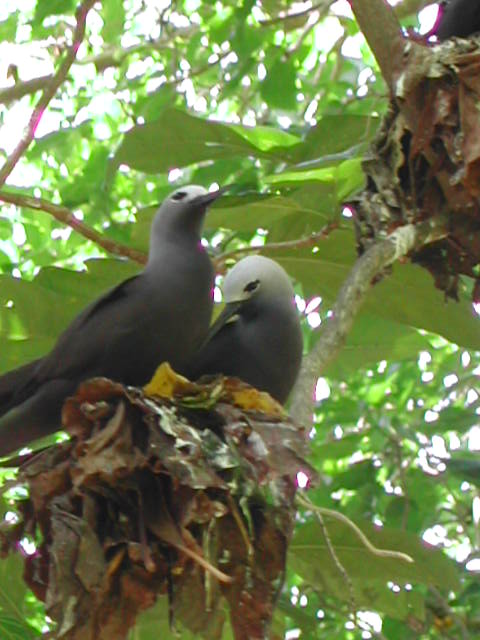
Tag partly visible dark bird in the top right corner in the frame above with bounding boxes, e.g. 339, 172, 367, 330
432, 0, 480, 40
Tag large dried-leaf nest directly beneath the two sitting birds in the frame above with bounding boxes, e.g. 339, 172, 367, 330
1, 365, 312, 640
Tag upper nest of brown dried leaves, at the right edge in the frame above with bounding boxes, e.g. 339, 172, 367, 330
357, 39, 480, 301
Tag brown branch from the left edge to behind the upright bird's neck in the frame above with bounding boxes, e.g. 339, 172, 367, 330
0, 191, 147, 265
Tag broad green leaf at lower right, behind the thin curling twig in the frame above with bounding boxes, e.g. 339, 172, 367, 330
289, 515, 458, 619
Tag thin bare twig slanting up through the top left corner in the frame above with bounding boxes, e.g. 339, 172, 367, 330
0, 0, 96, 188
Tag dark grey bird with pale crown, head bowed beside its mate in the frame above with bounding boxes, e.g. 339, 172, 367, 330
184, 256, 303, 404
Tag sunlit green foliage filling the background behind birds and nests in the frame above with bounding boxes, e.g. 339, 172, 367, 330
0, 0, 480, 640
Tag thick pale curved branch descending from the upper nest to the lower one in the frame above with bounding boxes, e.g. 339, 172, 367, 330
290, 217, 447, 425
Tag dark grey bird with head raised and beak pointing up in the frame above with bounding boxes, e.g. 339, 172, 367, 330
0, 185, 222, 455
